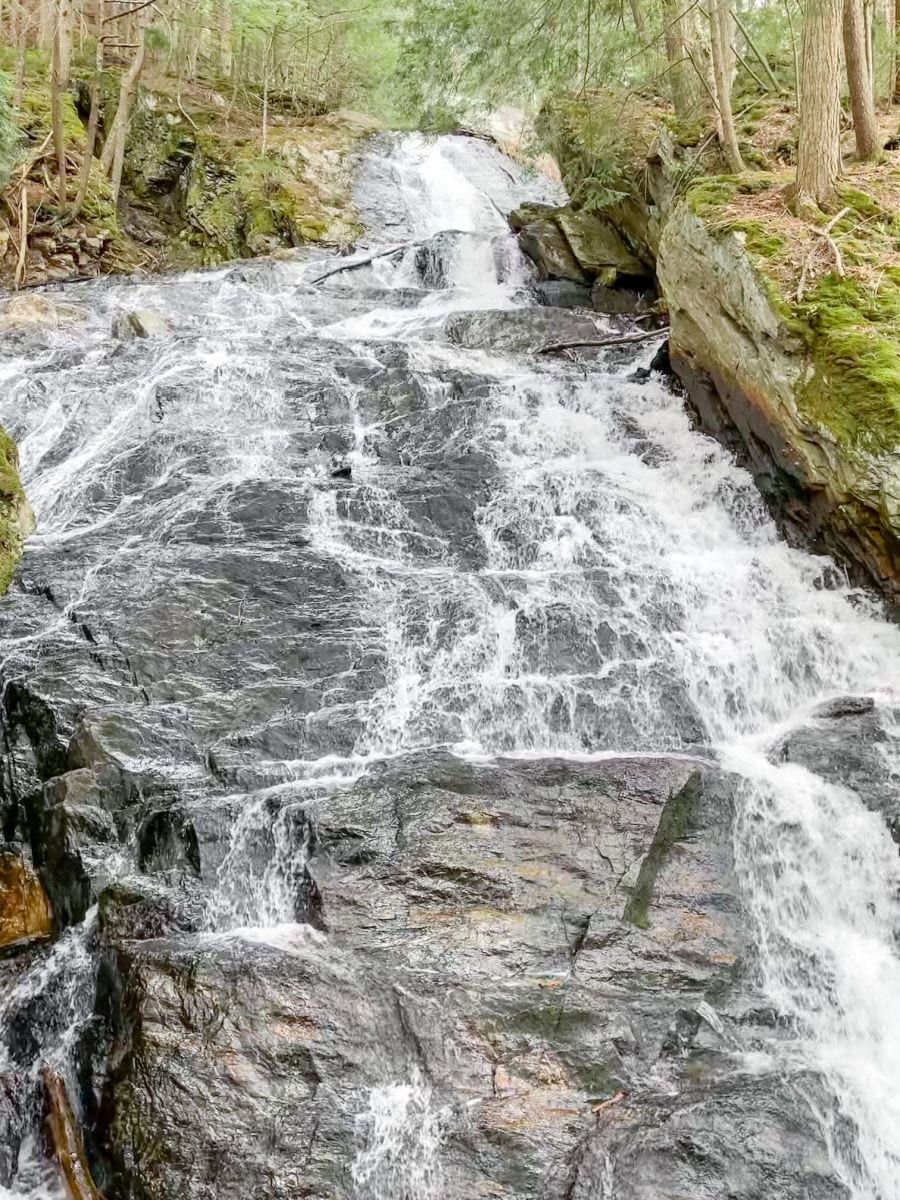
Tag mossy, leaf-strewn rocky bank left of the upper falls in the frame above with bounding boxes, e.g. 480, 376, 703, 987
0, 43, 378, 287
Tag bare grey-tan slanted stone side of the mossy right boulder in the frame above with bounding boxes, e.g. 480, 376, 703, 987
658, 203, 900, 599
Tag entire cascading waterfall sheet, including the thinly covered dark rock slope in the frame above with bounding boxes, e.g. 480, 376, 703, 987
0, 137, 900, 1200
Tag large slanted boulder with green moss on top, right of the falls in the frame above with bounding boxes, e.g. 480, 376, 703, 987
658, 198, 900, 596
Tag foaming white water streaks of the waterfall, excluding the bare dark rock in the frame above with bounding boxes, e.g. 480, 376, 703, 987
5, 138, 900, 1200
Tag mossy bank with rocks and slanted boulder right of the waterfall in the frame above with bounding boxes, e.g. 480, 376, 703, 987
525, 97, 900, 604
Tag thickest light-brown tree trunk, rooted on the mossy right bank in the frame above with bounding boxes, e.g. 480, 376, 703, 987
796, 0, 842, 209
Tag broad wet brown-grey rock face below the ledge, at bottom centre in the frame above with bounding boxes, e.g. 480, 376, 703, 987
97, 756, 844, 1200
